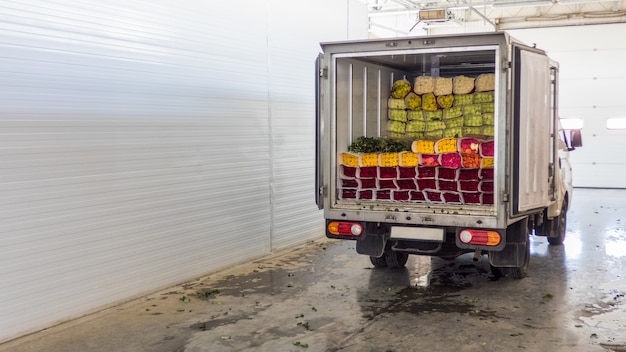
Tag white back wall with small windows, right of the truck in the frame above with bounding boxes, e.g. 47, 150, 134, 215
510, 24, 626, 188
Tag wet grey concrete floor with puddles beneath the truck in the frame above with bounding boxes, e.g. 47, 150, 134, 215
0, 189, 626, 352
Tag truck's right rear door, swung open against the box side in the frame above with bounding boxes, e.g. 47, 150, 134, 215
511, 44, 553, 215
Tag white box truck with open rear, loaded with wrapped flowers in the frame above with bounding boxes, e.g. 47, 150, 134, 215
315, 32, 582, 278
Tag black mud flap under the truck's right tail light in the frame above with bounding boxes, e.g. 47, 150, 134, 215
489, 218, 529, 268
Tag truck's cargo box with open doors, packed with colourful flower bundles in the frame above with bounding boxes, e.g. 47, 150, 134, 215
319, 33, 554, 227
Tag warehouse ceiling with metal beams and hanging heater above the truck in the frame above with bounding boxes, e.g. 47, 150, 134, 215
366, 0, 626, 35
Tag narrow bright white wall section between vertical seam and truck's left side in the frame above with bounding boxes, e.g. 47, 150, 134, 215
268, 0, 367, 248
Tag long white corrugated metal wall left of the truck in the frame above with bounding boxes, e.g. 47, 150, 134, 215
0, 0, 367, 341
